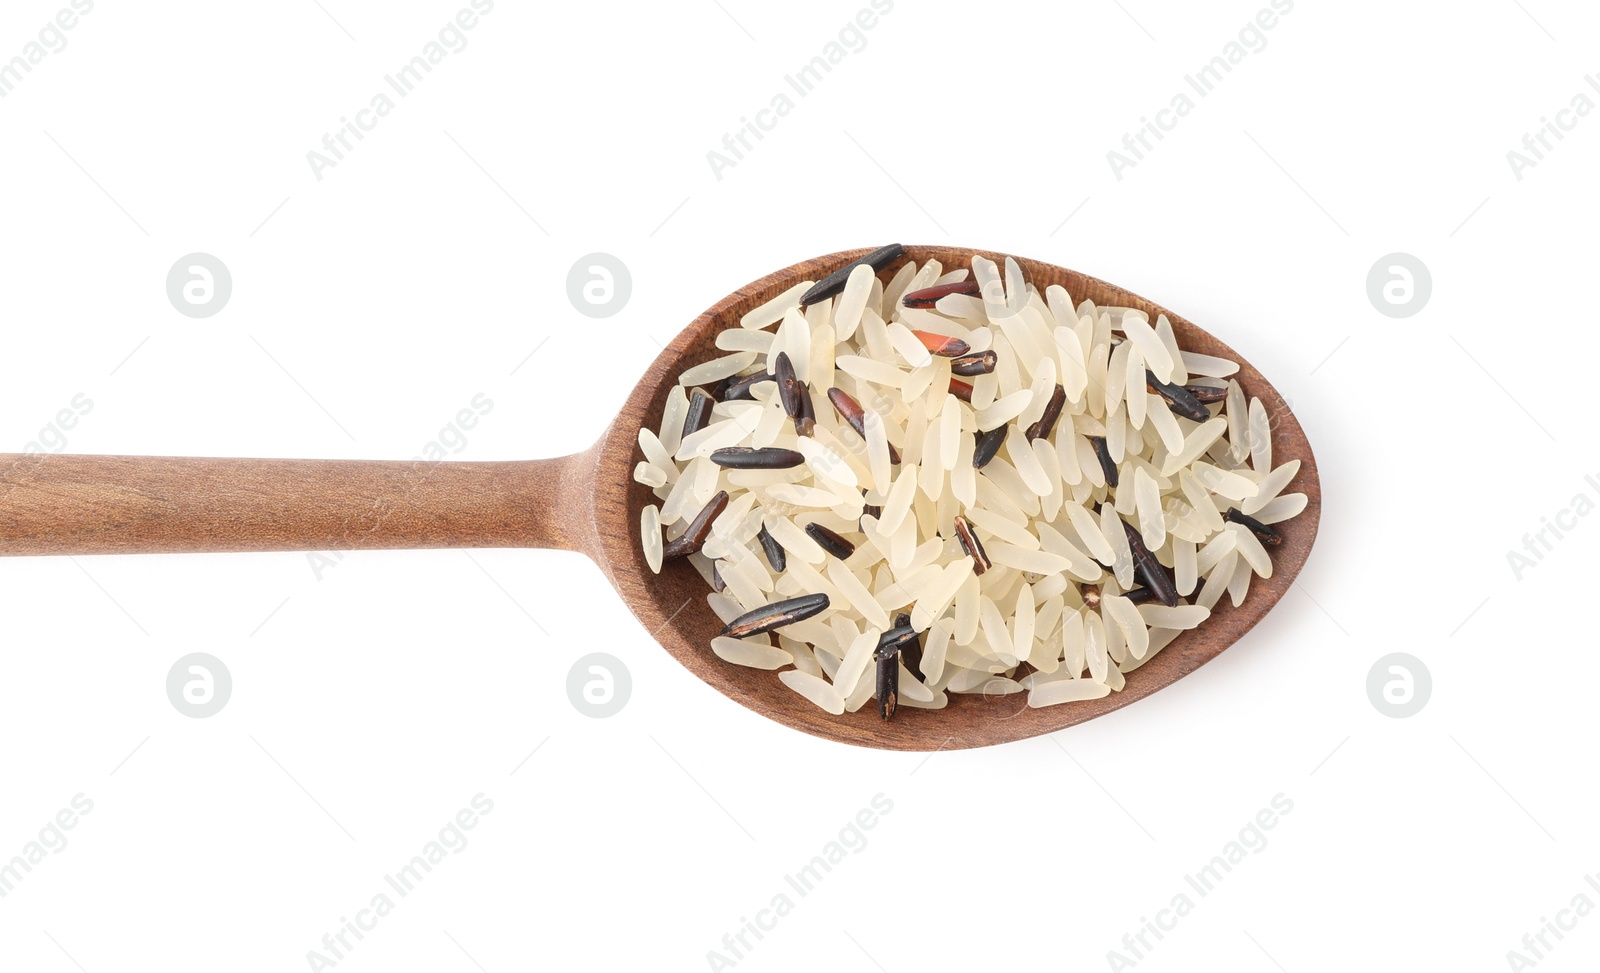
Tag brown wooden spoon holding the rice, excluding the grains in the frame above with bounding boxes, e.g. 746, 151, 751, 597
0, 246, 1322, 751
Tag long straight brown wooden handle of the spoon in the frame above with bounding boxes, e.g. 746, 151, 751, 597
0, 453, 595, 555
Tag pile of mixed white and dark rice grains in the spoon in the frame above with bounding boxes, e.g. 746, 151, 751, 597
634, 254, 1306, 717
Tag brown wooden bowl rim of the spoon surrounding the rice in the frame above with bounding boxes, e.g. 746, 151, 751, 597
590, 245, 1322, 751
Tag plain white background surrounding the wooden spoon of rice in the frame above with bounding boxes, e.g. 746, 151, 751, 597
0, 0, 1600, 973
